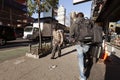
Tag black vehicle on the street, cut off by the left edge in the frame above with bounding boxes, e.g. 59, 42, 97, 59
0, 25, 16, 45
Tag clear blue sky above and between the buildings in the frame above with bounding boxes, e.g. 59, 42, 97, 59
32, 0, 92, 18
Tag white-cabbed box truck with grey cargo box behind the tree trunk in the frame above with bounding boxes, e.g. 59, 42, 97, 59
23, 22, 52, 41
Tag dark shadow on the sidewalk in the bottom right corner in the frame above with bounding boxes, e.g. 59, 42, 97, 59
104, 55, 120, 80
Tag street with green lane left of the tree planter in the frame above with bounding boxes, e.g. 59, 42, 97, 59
0, 38, 50, 62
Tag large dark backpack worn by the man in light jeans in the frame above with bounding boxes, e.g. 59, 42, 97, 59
75, 18, 93, 43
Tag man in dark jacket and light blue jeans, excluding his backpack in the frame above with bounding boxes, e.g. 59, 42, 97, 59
70, 12, 90, 80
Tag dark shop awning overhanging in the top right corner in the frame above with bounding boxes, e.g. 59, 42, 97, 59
96, 0, 120, 22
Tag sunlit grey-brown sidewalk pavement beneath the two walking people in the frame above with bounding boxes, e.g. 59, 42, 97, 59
0, 46, 105, 80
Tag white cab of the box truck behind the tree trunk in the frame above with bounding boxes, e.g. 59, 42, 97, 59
23, 23, 43, 40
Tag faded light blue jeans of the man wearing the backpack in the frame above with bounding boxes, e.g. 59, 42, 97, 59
75, 44, 89, 80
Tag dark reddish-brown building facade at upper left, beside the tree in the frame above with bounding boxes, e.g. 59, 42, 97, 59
0, 0, 34, 28
